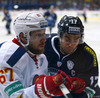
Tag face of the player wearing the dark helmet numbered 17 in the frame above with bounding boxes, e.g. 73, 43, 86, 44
60, 34, 81, 54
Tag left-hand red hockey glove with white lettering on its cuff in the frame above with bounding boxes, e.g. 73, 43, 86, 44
35, 74, 63, 98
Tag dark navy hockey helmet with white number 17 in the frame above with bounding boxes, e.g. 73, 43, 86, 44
58, 15, 84, 43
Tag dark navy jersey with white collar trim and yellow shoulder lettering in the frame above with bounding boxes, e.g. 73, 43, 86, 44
45, 36, 100, 98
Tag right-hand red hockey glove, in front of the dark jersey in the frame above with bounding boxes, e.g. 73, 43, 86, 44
70, 77, 85, 93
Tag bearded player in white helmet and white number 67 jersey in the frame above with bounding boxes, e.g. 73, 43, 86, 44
0, 13, 85, 98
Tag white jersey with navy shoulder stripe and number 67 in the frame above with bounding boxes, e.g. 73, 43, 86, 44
0, 41, 48, 98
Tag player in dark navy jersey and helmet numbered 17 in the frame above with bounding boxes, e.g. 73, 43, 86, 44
45, 15, 100, 98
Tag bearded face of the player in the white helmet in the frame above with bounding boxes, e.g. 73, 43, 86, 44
28, 29, 46, 54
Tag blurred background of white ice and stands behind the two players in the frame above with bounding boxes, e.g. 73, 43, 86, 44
0, 0, 100, 85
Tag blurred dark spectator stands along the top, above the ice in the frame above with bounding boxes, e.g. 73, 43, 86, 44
0, 0, 100, 10
